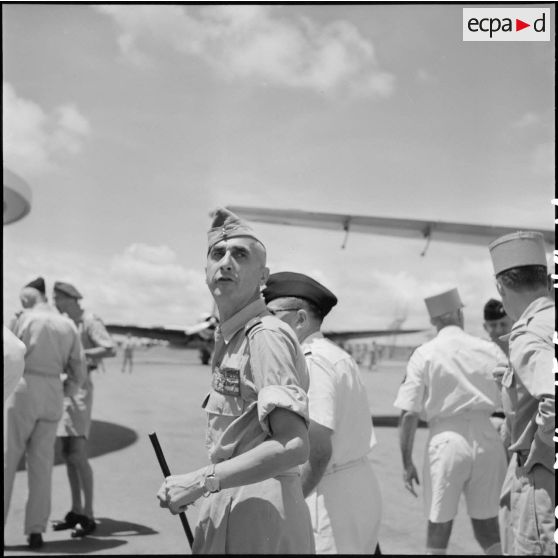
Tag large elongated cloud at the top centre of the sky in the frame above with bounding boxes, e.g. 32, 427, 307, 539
97, 5, 394, 97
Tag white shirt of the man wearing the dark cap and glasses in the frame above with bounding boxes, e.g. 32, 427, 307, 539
302, 332, 376, 472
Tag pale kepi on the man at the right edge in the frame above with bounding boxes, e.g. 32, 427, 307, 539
488, 231, 546, 275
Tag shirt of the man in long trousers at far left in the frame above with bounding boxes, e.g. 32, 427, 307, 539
9, 303, 85, 391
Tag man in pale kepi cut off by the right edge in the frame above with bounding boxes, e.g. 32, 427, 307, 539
489, 231, 556, 556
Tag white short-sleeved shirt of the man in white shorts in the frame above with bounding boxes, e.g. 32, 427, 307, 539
394, 325, 505, 421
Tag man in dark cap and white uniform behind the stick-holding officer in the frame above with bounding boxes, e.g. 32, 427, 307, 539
263, 271, 382, 554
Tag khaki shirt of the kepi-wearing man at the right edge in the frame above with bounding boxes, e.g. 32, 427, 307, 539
502, 297, 556, 471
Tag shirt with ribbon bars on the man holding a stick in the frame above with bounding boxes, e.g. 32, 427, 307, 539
203, 297, 309, 463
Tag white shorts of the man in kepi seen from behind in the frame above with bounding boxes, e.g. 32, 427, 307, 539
423, 413, 507, 523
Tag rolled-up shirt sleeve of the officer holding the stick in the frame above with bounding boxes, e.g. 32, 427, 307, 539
250, 330, 309, 432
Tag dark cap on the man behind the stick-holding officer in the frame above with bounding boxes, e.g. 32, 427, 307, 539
262, 271, 337, 316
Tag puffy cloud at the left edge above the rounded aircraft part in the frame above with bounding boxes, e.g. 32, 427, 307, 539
2, 82, 91, 176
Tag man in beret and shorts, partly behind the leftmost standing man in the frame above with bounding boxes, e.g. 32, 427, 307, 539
53, 281, 116, 537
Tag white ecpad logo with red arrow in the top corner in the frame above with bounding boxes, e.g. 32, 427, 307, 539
463, 7, 551, 41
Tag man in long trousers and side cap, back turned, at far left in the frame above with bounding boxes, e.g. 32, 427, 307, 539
4, 278, 85, 549
